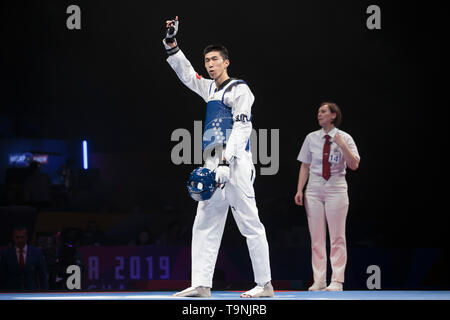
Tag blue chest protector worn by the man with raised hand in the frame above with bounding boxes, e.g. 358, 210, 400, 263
202, 80, 251, 151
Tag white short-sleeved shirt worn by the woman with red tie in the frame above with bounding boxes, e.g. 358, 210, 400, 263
297, 128, 360, 176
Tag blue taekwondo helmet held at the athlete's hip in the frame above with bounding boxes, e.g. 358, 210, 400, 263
187, 167, 217, 201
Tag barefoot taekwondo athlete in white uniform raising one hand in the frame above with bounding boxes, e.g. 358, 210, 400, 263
163, 17, 274, 298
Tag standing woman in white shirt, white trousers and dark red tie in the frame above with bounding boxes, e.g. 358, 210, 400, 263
295, 102, 360, 291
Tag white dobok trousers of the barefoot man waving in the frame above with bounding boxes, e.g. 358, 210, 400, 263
191, 152, 271, 288
